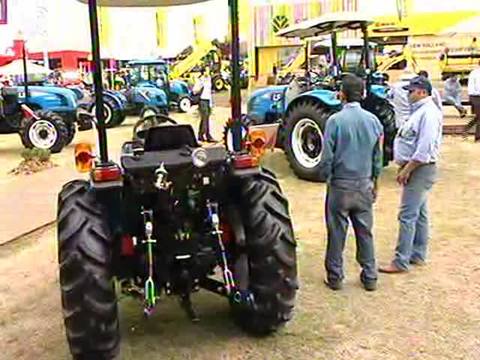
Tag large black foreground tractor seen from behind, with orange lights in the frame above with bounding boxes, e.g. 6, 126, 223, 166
57, 0, 298, 359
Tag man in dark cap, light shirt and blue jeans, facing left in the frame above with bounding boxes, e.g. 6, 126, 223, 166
379, 76, 443, 273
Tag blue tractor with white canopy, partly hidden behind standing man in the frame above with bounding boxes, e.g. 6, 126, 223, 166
248, 13, 396, 181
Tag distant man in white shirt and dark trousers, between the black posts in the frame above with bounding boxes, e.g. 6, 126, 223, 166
194, 67, 215, 142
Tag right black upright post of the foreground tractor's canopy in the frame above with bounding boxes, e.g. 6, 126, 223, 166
229, 0, 242, 151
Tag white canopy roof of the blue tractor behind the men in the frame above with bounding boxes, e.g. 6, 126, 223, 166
277, 12, 373, 39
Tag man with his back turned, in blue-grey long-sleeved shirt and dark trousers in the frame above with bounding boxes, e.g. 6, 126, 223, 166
320, 75, 383, 291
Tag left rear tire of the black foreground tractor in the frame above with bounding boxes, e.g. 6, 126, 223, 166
57, 180, 120, 360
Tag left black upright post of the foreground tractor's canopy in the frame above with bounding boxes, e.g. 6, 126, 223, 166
88, 0, 108, 163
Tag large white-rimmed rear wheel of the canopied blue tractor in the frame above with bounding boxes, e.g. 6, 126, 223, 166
283, 100, 335, 182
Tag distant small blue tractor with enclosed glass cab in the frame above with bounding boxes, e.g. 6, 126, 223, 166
124, 60, 198, 117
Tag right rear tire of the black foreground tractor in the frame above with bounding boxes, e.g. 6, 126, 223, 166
232, 169, 298, 336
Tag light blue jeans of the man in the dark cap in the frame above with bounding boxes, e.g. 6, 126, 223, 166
394, 164, 437, 270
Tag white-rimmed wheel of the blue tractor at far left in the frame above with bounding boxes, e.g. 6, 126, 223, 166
19, 110, 69, 154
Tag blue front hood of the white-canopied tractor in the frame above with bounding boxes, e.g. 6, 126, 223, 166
247, 85, 288, 124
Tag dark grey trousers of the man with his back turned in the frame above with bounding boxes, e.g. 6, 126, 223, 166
325, 180, 377, 281
